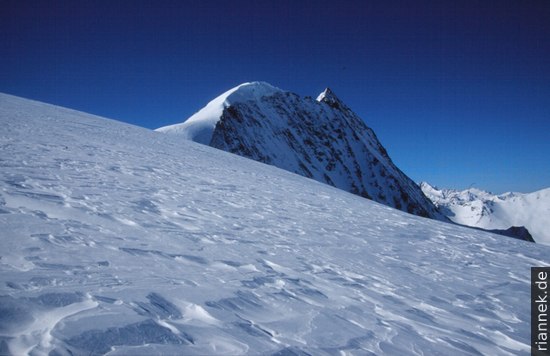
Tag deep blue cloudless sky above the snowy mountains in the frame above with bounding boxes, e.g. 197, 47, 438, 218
0, 0, 550, 193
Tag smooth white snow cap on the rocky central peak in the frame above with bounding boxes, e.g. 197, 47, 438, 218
156, 81, 282, 145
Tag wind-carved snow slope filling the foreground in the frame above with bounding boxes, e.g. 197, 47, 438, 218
0, 95, 550, 355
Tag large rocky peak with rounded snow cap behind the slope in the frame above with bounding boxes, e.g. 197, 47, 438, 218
157, 82, 447, 221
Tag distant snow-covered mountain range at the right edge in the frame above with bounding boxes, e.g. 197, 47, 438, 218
420, 182, 550, 245
